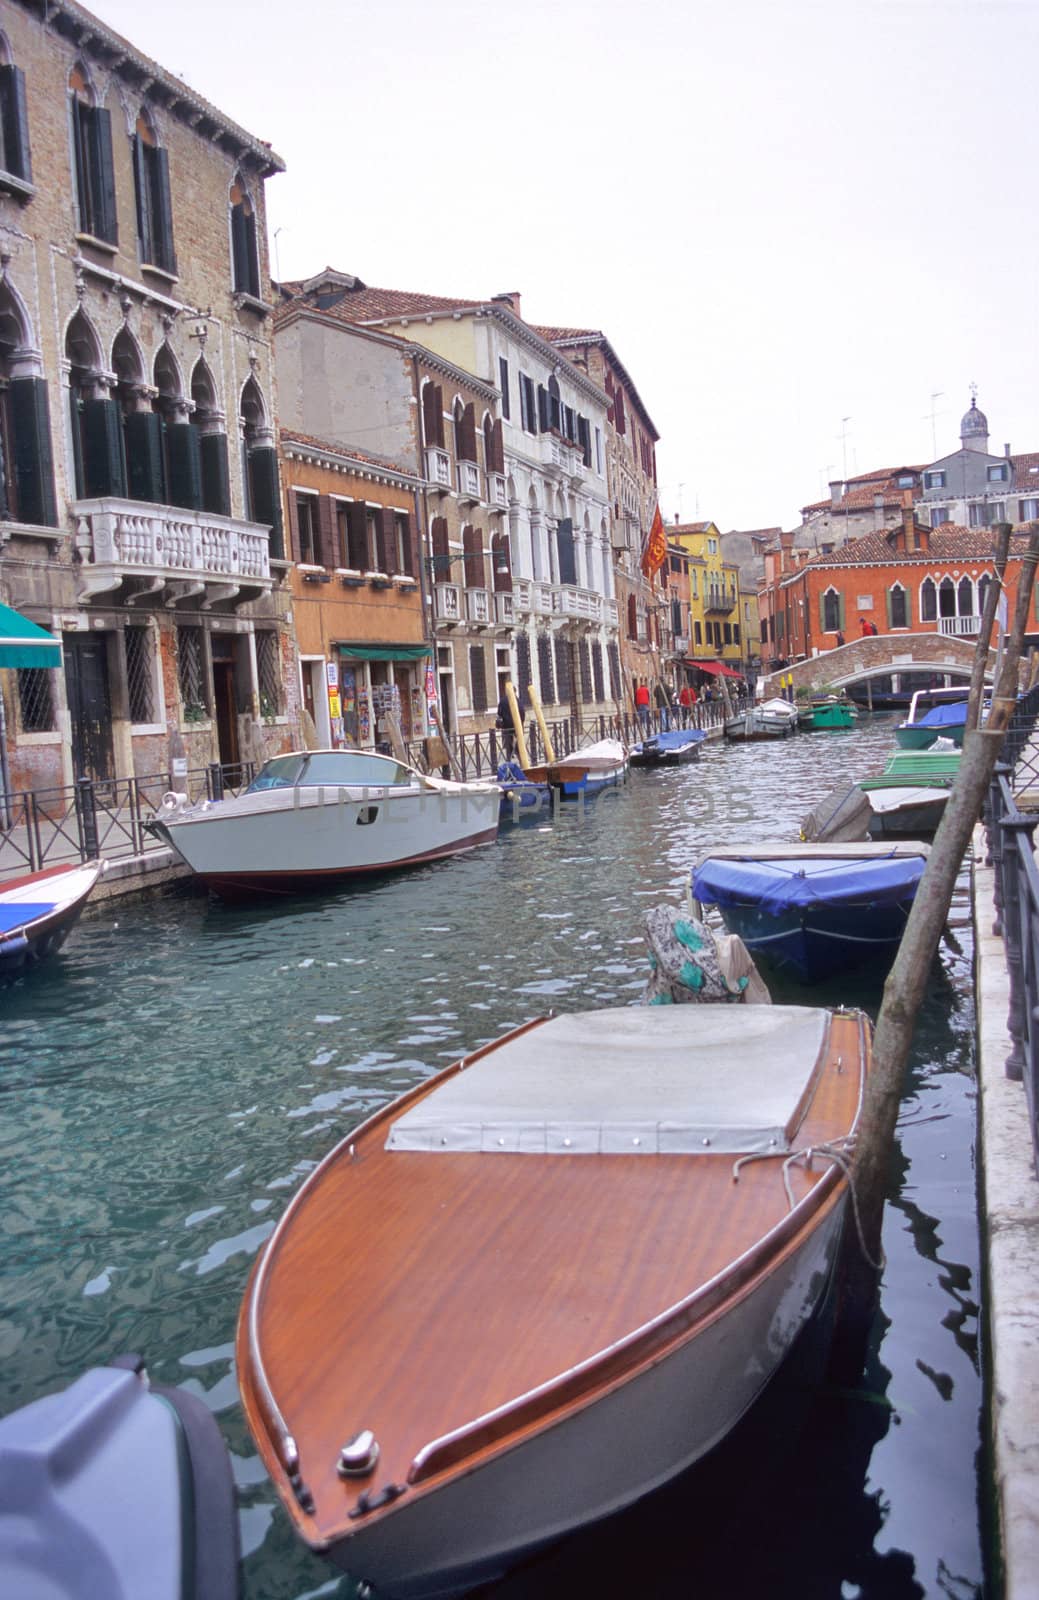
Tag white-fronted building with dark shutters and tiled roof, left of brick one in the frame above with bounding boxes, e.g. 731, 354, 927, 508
291, 278, 623, 722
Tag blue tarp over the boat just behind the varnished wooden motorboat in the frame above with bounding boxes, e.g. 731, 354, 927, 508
693, 856, 927, 917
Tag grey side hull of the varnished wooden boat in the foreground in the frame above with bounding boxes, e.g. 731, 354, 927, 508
315, 1192, 845, 1600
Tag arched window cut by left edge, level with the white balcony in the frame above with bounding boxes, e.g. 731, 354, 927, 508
0, 278, 58, 528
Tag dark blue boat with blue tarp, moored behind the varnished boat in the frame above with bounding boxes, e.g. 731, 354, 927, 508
693, 842, 930, 982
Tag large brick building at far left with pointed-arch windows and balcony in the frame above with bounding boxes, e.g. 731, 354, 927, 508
0, 0, 283, 790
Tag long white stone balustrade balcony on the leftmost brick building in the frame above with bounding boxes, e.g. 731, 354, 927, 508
72, 496, 274, 606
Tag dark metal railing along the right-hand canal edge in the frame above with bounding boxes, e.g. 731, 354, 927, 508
985, 686, 1039, 1173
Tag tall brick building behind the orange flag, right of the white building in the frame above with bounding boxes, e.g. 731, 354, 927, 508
536, 328, 665, 707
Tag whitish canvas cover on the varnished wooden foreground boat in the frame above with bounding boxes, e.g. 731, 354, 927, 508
386, 1005, 829, 1155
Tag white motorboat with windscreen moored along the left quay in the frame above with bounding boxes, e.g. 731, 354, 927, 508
149, 750, 501, 894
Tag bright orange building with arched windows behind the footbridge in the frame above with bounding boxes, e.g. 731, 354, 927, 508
759, 507, 1036, 670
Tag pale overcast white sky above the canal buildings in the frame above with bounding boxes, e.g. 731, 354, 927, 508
93, 0, 1039, 530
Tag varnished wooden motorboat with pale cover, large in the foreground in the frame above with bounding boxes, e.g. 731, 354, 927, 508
237, 1005, 869, 1595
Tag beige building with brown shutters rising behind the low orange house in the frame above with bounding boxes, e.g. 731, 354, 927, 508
277, 270, 512, 738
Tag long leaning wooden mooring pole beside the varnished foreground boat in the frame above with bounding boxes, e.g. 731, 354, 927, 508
842, 523, 1039, 1323
